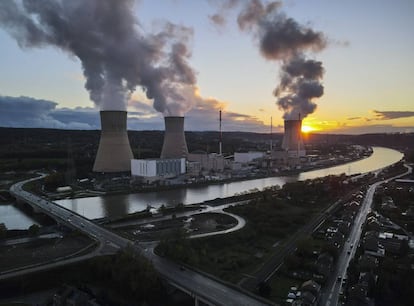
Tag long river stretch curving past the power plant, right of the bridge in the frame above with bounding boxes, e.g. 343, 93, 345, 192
56, 147, 403, 219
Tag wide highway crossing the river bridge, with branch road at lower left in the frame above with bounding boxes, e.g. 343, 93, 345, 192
8, 174, 271, 306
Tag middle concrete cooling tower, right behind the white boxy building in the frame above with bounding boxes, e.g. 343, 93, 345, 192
161, 117, 188, 158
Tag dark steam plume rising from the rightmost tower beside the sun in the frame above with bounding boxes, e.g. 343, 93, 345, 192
237, 0, 326, 119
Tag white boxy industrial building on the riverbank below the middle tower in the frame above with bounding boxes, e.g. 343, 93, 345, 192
131, 158, 186, 183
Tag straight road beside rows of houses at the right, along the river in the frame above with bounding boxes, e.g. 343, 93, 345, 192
319, 165, 412, 306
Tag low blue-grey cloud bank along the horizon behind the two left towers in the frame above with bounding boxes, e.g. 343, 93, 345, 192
0, 92, 269, 132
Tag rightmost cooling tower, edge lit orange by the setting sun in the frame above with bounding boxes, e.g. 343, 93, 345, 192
282, 120, 306, 157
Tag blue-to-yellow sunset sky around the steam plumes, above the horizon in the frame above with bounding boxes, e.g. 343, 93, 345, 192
0, 0, 414, 134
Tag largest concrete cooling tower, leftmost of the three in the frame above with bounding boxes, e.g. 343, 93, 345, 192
93, 111, 134, 172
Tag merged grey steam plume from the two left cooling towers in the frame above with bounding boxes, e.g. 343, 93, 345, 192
0, 0, 196, 115
